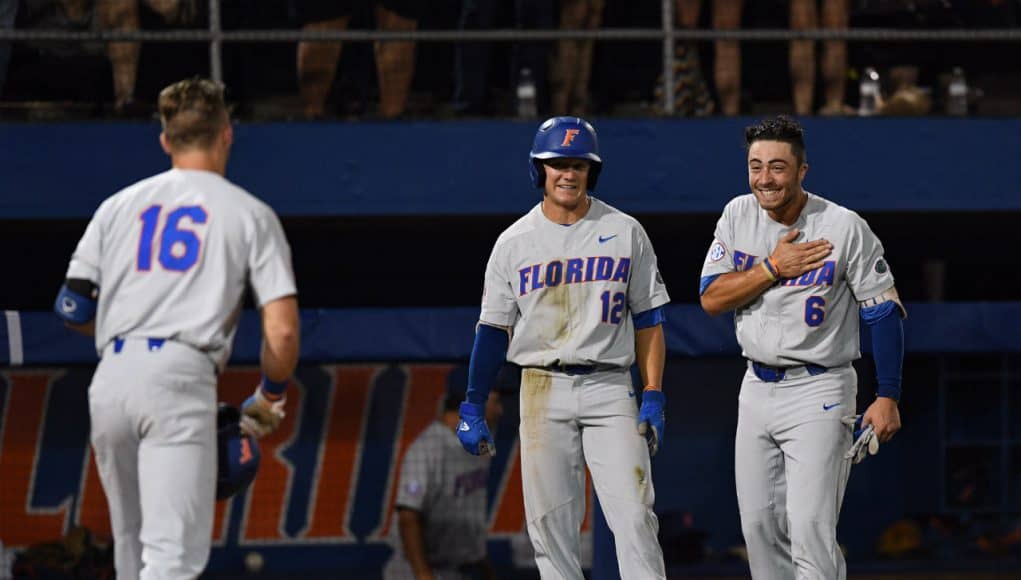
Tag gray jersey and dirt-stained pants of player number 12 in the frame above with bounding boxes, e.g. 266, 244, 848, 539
480, 198, 670, 580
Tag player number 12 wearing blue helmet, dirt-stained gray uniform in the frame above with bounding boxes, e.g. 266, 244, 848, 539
457, 116, 670, 580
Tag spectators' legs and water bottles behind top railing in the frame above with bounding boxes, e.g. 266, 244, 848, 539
0, 0, 1021, 120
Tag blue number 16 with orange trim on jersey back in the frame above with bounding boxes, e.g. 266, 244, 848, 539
138, 205, 208, 272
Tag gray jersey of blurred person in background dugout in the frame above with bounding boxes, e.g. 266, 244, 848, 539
384, 421, 490, 578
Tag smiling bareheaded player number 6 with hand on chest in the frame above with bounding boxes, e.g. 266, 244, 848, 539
699, 116, 906, 580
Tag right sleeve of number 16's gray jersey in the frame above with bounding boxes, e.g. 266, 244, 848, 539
248, 207, 297, 307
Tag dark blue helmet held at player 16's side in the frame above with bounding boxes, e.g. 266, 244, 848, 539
216, 403, 261, 499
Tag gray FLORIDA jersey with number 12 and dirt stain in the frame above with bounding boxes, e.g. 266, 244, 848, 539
480, 198, 670, 368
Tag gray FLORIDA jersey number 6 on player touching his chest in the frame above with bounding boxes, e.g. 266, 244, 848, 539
701, 193, 893, 367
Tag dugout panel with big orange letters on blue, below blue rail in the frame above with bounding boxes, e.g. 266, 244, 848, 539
0, 364, 589, 571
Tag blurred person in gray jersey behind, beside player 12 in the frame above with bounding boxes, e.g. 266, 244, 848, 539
383, 388, 503, 580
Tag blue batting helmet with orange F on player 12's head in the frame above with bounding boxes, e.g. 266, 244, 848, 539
528, 116, 602, 191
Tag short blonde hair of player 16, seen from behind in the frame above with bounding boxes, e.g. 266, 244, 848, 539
159, 77, 230, 149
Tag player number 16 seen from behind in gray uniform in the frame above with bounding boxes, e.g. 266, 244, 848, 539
54, 79, 298, 579
